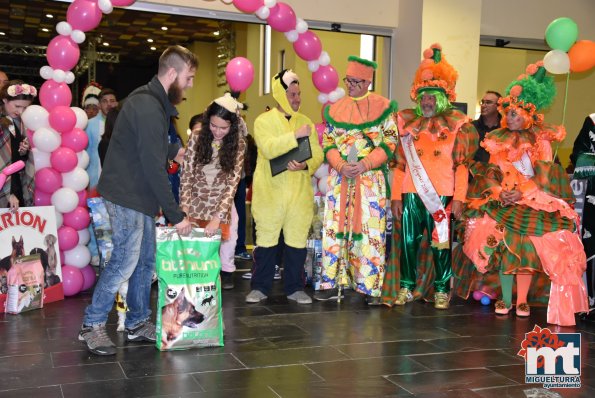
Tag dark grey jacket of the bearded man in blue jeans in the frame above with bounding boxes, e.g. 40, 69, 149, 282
97, 76, 184, 224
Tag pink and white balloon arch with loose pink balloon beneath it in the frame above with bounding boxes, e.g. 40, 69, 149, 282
23, 0, 345, 295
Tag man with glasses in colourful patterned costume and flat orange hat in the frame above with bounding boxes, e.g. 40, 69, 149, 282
314, 56, 397, 305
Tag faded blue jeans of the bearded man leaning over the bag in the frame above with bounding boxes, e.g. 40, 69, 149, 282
83, 200, 156, 328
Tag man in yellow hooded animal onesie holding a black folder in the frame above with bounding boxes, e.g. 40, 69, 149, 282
246, 70, 323, 304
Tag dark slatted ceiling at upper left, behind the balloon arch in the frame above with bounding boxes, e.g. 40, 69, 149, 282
0, 0, 224, 69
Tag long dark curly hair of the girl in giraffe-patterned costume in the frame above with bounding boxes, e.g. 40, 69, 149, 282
194, 102, 240, 173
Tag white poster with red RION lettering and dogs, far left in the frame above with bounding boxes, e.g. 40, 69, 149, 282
0, 206, 64, 312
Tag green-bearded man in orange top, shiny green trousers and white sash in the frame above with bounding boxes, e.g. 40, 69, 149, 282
383, 44, 478, 309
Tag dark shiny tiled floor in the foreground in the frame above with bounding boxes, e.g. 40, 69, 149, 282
0, 264, 595, 398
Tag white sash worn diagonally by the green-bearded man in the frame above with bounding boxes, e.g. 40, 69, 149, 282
400, 134, 450, 243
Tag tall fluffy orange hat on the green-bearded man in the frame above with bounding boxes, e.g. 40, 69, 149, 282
410, 43, 459, 102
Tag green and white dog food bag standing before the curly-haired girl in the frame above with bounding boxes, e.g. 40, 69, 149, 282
156, 227, 223, 351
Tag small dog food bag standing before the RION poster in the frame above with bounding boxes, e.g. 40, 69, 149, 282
6, 255, 44, 314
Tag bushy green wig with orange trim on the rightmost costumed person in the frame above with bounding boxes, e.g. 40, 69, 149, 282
498, 61, 556, 124
